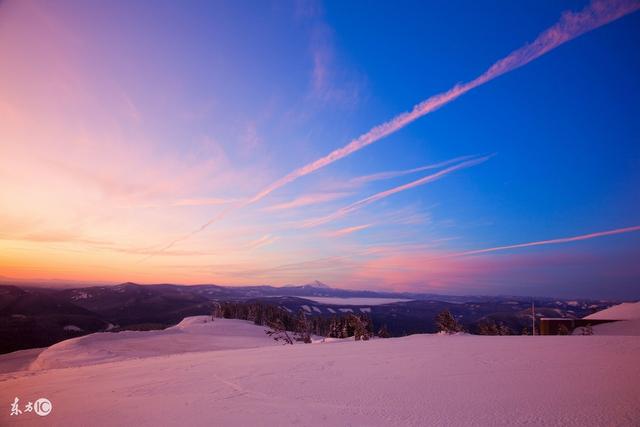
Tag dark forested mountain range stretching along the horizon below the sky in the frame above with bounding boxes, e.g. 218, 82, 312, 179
0, 281, 612, 353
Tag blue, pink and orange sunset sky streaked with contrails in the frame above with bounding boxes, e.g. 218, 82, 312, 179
0, 0, 640, 299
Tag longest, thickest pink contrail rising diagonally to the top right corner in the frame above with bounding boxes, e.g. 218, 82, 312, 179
148, 0, 640, 254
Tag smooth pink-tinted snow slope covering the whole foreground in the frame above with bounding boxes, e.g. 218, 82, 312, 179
0, 317, 640, 426
